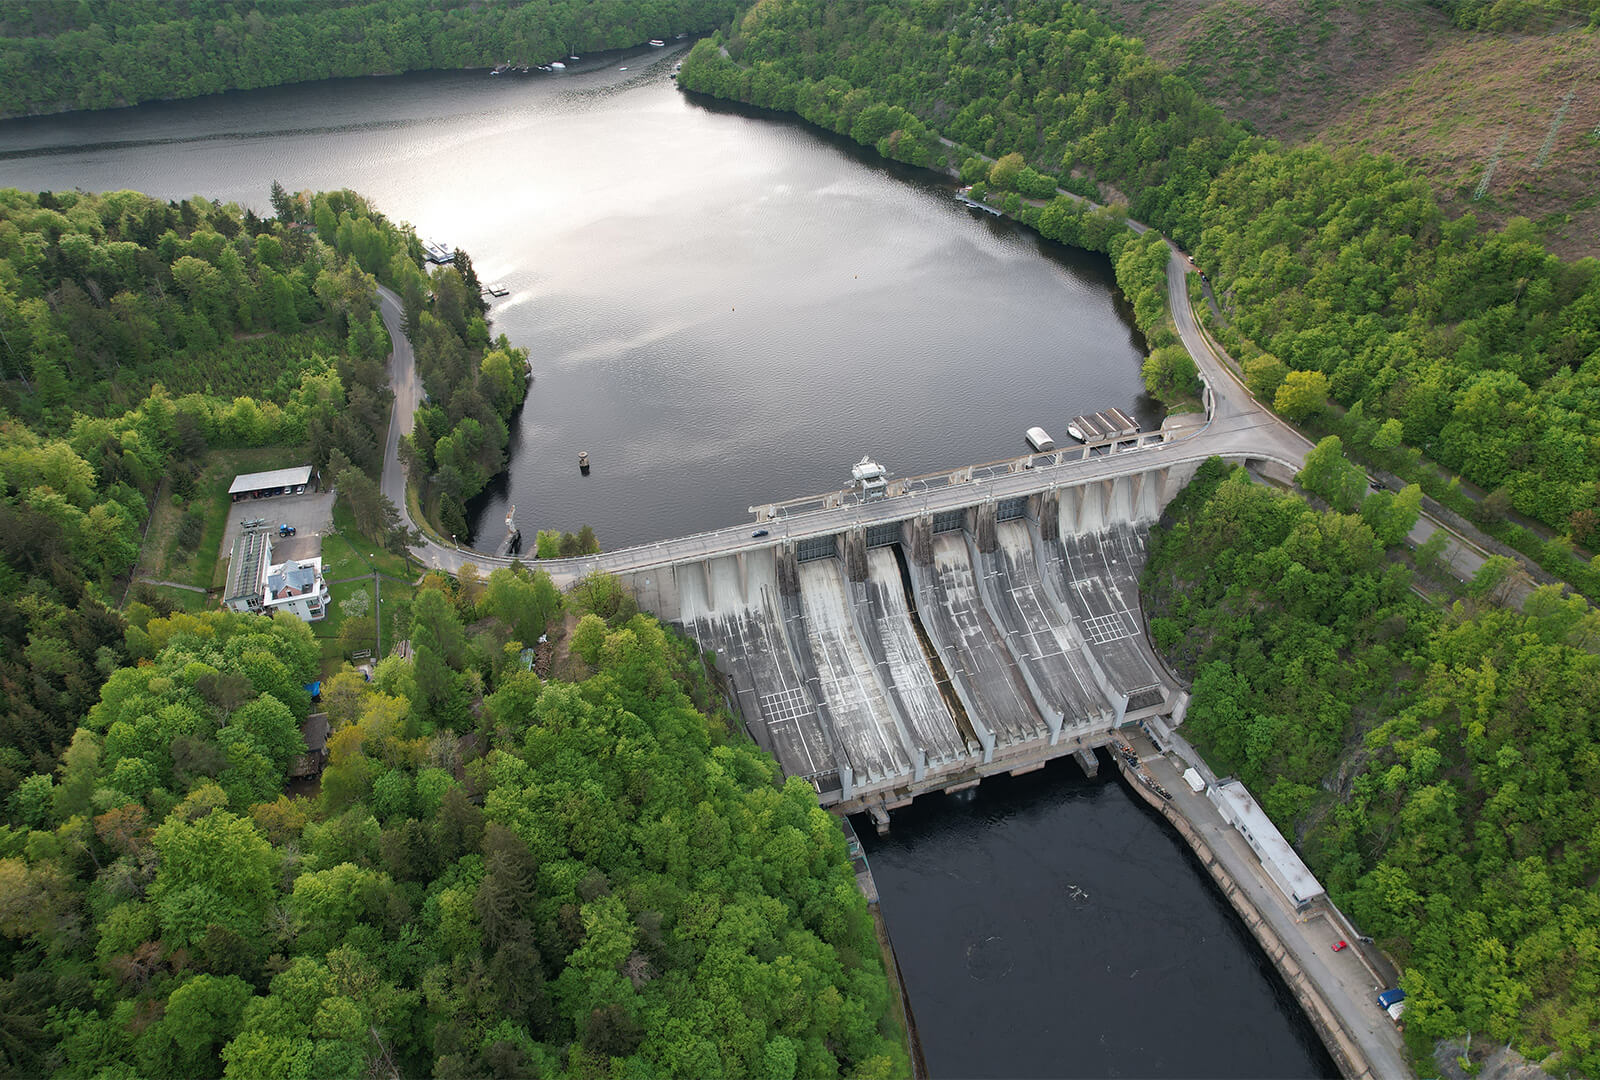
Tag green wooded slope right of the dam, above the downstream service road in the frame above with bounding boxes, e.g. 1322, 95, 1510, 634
1142, 457, 1600, 1075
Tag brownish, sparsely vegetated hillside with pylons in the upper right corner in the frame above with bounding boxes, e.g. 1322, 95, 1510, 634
1090, 0, 1600, 258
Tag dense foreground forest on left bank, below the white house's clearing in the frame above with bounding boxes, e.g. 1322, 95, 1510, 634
0, 568, 909, 1080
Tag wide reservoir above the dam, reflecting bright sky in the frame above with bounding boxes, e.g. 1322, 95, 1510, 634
0, 46, 1160, 549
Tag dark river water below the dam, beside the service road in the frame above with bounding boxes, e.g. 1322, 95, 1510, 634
856, 760, 1338, 1077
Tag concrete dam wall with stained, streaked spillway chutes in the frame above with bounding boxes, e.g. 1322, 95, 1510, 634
622, 456, 1197, 824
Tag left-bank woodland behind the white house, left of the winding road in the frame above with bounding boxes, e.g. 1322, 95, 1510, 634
0, 189, 421, 792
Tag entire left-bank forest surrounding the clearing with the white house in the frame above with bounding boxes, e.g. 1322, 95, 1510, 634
0, 175, 909, 1080
